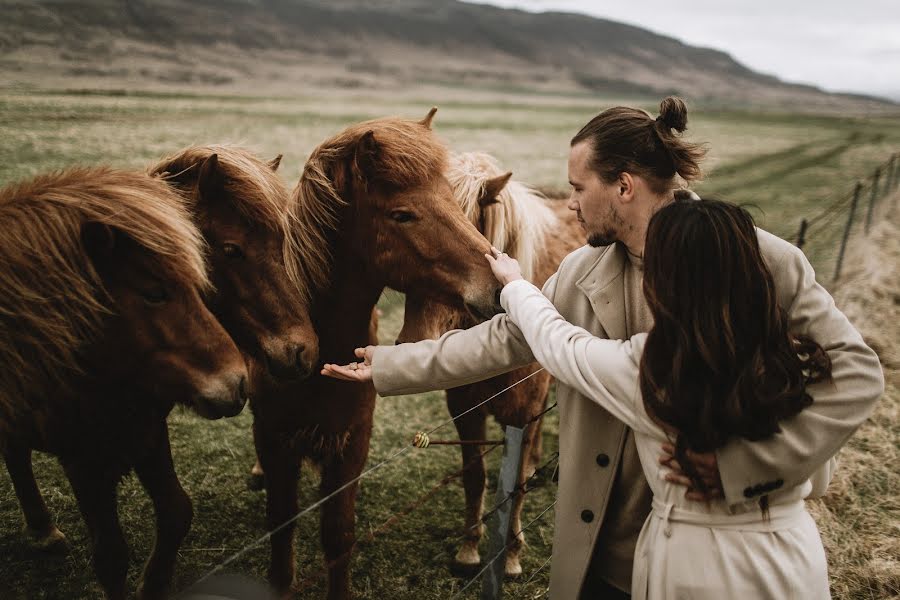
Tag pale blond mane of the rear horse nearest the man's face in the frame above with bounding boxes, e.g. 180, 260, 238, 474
447, 152, 557, 281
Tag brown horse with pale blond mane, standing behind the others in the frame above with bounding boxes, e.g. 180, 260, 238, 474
398, 152, 584, 577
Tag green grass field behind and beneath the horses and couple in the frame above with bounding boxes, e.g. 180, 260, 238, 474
0, 85, 900, 600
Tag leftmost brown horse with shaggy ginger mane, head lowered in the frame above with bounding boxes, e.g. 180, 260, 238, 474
0, 168, 247, 599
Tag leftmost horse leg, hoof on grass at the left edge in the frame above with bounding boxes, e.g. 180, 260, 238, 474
3, 442, 68, 551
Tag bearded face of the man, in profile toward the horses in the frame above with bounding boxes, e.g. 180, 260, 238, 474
568, 141, 624, 247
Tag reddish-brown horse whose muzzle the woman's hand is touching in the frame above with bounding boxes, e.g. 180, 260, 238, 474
251, 110, 499, 599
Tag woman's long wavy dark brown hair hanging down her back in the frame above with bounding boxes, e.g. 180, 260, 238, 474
640, 200, 831, 500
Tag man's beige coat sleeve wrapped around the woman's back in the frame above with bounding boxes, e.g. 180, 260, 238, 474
717, 240, 884, 505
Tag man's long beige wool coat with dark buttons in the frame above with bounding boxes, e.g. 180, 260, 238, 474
372, 230, 884, 600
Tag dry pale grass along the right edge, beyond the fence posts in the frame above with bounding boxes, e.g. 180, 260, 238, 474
810, 195, 900, 600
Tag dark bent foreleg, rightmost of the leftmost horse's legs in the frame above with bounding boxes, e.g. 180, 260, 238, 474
134, 421, 194, 600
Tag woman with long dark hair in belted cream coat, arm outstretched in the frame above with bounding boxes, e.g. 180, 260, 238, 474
325, 200, 830, 599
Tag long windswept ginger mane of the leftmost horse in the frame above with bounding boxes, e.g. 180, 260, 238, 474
0, 167, 210, 422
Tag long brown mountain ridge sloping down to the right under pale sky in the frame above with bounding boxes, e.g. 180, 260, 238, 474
0, 0, 887, 107
